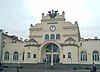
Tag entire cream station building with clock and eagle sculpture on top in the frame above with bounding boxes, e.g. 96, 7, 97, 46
0, 11, 100, 64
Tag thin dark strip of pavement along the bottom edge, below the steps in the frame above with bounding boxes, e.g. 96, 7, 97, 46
0, 68, 100, 72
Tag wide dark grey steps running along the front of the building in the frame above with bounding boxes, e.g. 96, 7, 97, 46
3, 63, 100, 70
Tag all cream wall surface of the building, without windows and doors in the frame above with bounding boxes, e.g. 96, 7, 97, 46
0, 10, 100, 64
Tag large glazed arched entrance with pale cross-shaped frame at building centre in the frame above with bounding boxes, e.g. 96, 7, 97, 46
42, 43, 60, 63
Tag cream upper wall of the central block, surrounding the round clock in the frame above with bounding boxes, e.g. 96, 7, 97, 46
29, 16, 78, 44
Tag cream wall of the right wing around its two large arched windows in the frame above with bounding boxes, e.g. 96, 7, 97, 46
79, 40, 100, 64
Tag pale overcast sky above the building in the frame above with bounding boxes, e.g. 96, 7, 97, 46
0, 0, 100, 39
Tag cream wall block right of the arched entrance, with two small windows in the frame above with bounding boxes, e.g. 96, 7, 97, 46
61, 46, 78, 64
